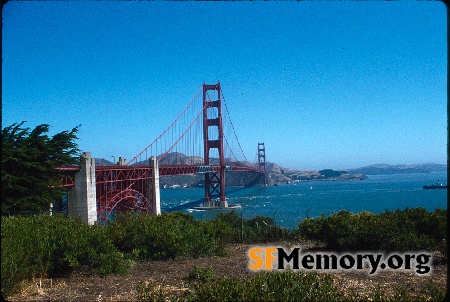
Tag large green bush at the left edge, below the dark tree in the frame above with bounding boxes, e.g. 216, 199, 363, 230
1, 215, 130, 296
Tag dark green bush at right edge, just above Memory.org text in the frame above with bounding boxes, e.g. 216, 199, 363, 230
298, 208, 447, 255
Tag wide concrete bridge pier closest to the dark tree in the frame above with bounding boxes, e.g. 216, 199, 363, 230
67, 152, 97, 225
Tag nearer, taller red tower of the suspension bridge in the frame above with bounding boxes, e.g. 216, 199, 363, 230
203, 82, 228, 208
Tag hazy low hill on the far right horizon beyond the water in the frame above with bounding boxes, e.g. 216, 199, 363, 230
348, 163, 447, 175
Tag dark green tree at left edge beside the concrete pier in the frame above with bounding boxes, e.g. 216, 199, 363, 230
1, 122, 80, 215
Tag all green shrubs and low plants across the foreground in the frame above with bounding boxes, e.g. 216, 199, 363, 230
1, 208, 447, 301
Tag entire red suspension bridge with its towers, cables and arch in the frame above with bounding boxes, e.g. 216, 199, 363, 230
59, 82, 265, 223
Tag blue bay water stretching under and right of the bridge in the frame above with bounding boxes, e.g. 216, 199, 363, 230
161, 172, 447, 228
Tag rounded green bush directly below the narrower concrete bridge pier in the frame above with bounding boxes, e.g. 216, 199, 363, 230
106, 212, 225, 260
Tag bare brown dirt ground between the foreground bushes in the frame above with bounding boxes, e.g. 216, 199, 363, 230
8, 242, 447, 301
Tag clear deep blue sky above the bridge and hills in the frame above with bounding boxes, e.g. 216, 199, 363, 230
2, 1, 447, 170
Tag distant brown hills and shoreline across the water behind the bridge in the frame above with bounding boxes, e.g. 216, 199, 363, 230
95, 152, 447, 188
